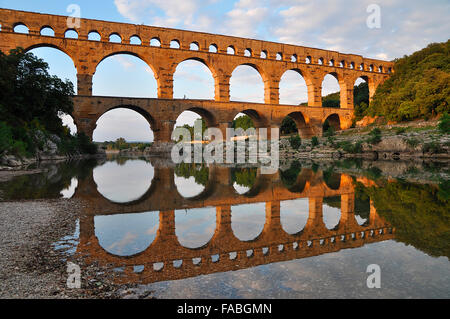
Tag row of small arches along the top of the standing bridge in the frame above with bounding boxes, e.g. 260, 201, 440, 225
9, 23, 392, 73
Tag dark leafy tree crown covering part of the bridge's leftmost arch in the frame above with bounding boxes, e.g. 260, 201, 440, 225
0, 48, 74, 134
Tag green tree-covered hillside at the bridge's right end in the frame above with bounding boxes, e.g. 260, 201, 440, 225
362, 40, 450, 121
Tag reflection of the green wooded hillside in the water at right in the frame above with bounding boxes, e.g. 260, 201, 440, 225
359, 182, 450, 257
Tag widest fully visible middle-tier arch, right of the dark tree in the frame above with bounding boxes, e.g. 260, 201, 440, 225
92, 51, 159, 98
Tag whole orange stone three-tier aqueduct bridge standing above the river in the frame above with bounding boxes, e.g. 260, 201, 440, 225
0, 9, 393, 142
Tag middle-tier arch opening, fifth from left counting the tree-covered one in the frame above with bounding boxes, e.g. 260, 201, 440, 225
279, 69, 308, 105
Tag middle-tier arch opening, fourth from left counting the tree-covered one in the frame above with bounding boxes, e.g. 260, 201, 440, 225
230, 64, 265, 103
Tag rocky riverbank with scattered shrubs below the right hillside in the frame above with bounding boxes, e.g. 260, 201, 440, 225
280, 121, 450, 161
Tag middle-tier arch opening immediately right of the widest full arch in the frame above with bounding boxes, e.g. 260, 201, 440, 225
173, 58, 215, 100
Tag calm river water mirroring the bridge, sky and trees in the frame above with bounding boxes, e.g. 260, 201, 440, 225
0, 157, 450, 298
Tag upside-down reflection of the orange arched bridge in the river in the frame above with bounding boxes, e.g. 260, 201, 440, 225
74, 161, 395, 284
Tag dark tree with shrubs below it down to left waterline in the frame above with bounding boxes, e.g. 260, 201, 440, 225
0, 48, 97, 157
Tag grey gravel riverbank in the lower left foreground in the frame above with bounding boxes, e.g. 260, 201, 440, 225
0, 199, 144, 299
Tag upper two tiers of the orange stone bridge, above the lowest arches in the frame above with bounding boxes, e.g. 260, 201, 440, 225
0, 9, 393, 109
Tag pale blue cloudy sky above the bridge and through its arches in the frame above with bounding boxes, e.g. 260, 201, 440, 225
0, 0, 450, 141
